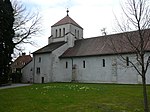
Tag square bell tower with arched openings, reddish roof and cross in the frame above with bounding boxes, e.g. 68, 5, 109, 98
48, 9, 83, 46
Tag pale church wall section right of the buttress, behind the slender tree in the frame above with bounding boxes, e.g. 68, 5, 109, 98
117, 53, 150, 84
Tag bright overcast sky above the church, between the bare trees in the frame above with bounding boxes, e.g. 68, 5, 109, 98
19, 0, 121, 53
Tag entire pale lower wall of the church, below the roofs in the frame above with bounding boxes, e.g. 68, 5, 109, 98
29, 49, 150, 84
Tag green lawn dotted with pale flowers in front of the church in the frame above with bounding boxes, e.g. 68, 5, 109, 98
0, 83, 150, 112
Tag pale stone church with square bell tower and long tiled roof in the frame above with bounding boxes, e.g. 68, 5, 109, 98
23, 10, 150, 84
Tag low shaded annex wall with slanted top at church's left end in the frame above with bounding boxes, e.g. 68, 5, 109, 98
22, 60, 33, 83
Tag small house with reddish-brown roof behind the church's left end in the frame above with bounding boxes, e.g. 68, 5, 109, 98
11, 53, 32, 82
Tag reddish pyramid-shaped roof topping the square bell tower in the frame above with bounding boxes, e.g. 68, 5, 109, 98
52, 15, 83, 29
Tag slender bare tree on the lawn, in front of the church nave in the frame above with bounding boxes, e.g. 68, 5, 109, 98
112, 0, 150, 112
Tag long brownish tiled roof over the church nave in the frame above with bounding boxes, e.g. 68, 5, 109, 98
61, 30, 150, 58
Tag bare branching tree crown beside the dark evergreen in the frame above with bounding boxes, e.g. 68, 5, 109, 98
12, 0, 41, 51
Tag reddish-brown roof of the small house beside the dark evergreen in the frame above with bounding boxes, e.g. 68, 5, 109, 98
11, 55, 32, 68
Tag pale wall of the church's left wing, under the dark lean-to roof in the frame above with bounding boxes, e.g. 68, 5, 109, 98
33, 43, 68, 83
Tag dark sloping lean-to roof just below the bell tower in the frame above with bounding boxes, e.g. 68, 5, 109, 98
33, 42, 66, 54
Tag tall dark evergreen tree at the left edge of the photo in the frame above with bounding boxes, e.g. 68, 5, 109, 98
0, 0, 14, 84
